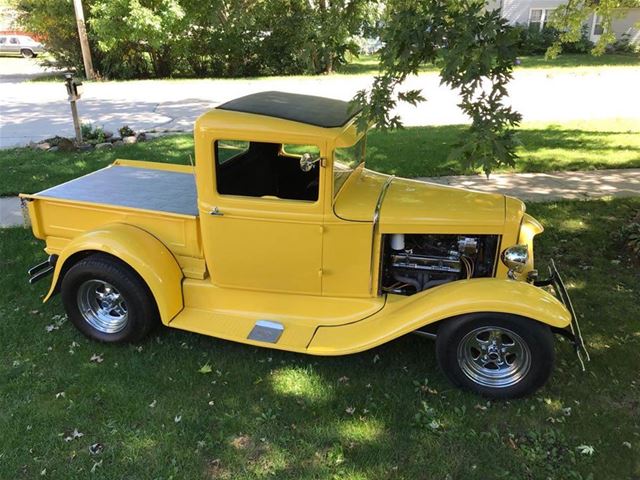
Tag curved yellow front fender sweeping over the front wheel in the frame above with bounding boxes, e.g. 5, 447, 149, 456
308, 278, 571, 355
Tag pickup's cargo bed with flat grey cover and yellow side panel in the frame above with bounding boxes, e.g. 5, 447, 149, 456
20, 160, 206, 278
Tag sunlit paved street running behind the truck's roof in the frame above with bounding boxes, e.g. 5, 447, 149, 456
0, 56, 640, 147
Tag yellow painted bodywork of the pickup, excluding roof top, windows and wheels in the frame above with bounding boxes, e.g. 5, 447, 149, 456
22, 102, 570, 355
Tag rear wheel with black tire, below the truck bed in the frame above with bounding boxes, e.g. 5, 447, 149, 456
61, 253, 159, 343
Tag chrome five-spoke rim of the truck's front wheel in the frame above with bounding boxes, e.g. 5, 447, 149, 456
458, 326, 531, 388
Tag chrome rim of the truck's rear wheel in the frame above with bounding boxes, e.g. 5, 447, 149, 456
78, 280, 129, 333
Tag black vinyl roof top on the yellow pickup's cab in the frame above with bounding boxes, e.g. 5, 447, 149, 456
217, 92, 361, 128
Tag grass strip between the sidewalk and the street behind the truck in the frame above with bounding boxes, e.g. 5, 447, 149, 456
0, 119, 640, 196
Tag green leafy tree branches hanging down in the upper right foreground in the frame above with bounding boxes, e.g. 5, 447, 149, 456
354, 0, 640, 175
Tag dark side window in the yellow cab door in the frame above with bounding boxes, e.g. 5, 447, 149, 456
214, 140, 320, 201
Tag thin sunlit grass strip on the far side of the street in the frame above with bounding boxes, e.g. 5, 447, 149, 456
337, 53, 640, 75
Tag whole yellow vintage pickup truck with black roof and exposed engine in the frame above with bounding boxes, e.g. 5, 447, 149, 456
21, 92, 586, 398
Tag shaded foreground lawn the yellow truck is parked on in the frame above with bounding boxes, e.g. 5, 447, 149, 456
0, 198, 640, 480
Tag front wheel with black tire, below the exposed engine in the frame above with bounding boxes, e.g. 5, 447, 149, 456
436, 313, 555, 399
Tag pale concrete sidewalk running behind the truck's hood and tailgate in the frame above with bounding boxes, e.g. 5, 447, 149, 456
0, 168, 640, 228
